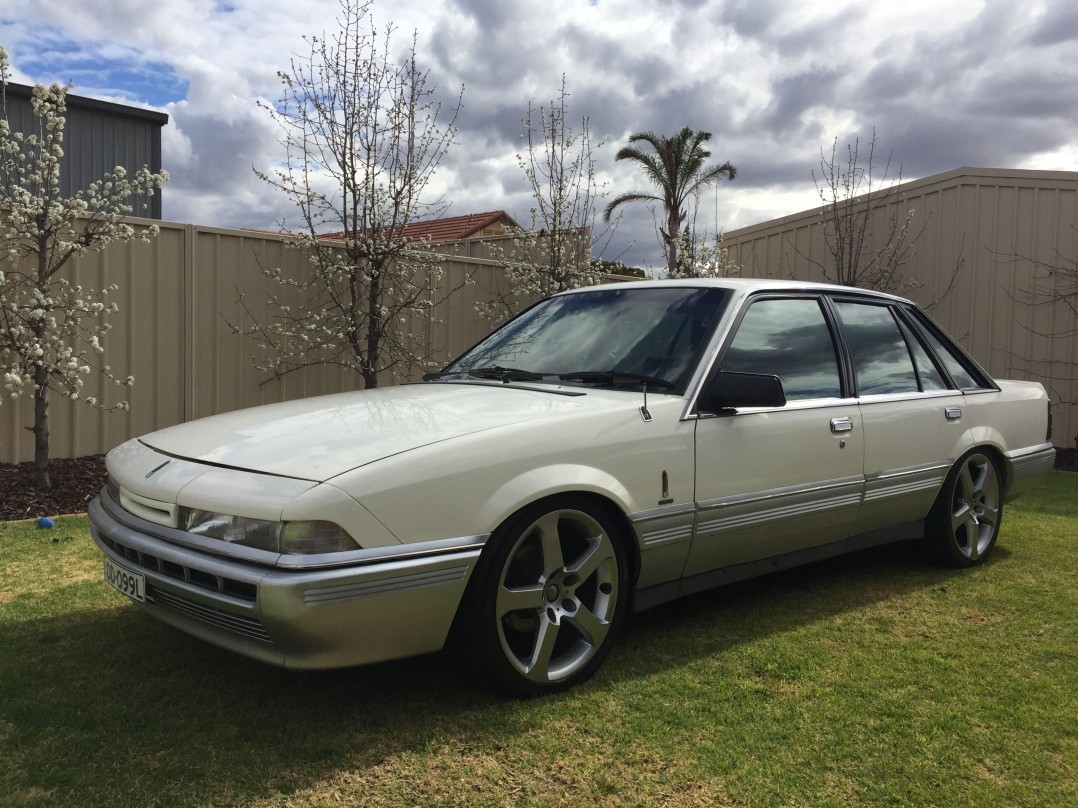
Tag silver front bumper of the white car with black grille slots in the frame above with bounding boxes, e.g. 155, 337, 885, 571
88, 490, 485, 669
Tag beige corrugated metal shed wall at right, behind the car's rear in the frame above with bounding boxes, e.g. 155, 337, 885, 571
723, 168, 1078, 446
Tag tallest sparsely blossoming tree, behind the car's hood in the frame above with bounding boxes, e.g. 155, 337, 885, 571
240, 0, 459, 388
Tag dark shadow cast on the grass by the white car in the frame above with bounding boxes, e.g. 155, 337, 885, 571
0, 538, 1006, 805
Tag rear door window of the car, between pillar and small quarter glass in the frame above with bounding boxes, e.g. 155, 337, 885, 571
834, 302, 921, 395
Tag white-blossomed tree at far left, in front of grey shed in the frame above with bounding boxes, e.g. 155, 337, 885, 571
0, 48, 168, 490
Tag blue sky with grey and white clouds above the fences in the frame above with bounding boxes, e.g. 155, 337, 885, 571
0, 0, 1078, 272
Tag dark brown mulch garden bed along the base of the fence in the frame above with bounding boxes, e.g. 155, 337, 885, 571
0, 448, 1078, 519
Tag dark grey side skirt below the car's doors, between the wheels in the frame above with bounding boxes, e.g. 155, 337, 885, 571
633, 519, 925, 612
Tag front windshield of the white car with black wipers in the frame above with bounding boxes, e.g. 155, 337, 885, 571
434, 285, 730, 392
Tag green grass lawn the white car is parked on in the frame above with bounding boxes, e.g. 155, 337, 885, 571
0, 473, 1078, 807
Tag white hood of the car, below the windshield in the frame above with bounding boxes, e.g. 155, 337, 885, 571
141, 382, 603, 482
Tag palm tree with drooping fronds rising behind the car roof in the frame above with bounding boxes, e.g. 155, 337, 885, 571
603, 126, 737, 273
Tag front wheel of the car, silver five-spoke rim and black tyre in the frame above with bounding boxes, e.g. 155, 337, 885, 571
458, 496, 630, 696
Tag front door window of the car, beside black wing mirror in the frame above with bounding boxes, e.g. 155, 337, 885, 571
722, 298, 842, 401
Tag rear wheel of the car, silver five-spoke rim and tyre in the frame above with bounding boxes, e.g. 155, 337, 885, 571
927, 449, 1004, 567
